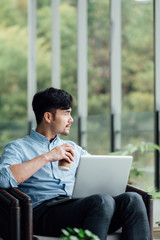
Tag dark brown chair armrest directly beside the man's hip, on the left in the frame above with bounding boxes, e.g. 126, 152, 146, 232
7, 188, 33, 240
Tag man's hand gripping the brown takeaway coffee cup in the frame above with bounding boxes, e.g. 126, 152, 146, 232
45, 144, 74, 162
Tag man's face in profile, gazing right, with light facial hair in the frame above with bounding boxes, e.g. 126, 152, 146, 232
52, 108, 73, 135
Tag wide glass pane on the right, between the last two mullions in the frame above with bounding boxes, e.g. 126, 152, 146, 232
121, 0, 154, 187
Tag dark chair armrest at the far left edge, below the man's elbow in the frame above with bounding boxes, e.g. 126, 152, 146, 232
0, 189, 20, 240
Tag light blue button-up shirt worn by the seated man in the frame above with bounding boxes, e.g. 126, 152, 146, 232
0, 129, 88, 207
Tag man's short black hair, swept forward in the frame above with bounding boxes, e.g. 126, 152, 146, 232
32, 87, 73, 124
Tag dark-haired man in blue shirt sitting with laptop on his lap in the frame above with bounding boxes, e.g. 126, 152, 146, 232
0, 88, 150, 240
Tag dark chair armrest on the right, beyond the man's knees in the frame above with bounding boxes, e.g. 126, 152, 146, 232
126, 184, 153, 239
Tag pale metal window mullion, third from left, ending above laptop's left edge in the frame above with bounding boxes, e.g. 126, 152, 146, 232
77, 0, 88, 148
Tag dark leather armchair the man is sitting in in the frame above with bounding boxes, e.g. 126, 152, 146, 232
0, 185, 153, 240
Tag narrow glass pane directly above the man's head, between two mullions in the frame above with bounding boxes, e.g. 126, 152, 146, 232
36, 0, 51, 90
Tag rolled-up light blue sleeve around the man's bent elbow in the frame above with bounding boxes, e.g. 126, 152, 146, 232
0, 144, 21, 188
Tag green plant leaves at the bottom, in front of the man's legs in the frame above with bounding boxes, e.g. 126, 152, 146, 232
60, 227, 99, 240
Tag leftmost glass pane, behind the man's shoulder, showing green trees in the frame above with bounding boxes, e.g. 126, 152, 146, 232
0, 0, 28, 154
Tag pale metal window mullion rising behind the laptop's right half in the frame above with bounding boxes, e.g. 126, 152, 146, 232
110, 0, 122, 150
